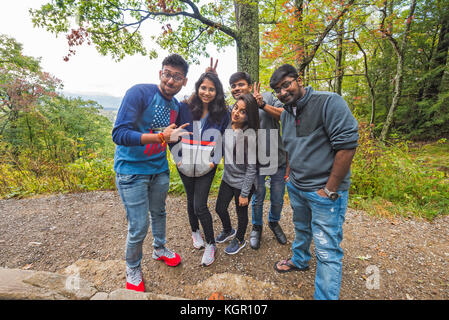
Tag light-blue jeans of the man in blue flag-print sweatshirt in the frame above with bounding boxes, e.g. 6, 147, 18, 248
116, 171, 170, 268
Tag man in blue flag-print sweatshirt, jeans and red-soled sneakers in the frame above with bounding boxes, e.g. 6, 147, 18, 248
112, 54, 189, 291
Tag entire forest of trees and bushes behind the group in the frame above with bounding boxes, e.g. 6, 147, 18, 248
0, 0, 449, 219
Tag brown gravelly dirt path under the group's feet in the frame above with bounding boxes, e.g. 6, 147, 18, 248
0, 191, 449, 299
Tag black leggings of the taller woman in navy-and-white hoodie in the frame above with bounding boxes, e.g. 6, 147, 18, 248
178, 168, 217, 244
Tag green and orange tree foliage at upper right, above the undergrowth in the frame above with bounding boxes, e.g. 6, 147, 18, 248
259, 0, 449, 140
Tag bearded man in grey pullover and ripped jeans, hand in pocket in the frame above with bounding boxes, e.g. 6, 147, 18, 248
270, 64, 359, 299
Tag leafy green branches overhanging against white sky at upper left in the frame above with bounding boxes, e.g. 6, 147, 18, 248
31, 0, 235, 62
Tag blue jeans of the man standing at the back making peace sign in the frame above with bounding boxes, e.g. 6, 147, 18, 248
251, 166, 286, 226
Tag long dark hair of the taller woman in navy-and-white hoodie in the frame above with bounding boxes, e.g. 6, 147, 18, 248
187, 72, 227, 124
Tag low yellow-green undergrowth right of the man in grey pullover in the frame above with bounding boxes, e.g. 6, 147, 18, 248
350, 124, 449, 219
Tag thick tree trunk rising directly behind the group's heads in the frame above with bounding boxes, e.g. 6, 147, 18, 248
234, 0, 259, 81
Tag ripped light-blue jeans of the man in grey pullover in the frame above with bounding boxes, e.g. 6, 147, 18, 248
287, 182, 348, 300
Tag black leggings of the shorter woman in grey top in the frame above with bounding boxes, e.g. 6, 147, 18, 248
215, 180, 254, 242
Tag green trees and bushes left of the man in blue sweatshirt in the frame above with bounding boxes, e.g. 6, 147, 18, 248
0, 36, 114, 198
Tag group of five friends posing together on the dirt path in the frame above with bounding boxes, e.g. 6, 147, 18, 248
112, 54, 358, 299
